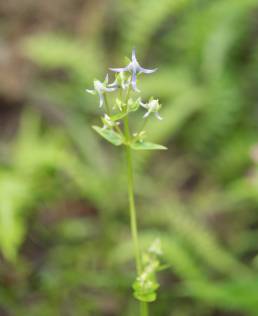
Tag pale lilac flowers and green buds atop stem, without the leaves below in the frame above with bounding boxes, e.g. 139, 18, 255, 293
86, 49, 162, 145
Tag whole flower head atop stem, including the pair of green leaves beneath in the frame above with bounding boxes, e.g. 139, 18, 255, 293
86, 49, 165, 149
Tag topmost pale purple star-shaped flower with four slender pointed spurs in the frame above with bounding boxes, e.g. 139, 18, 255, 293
110, 49, 157, 92
